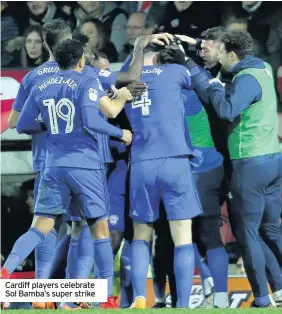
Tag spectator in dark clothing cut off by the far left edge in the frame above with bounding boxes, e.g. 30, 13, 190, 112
1, 1, 19, 67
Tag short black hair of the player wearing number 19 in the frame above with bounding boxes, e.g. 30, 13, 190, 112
54, 39, 83, 70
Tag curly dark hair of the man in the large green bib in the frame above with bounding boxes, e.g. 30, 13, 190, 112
223, 30, 254, 60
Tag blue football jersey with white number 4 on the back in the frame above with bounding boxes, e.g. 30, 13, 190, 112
125, 64, 192, 162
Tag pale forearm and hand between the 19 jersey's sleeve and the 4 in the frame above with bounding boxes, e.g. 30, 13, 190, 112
99, 86, 132, 119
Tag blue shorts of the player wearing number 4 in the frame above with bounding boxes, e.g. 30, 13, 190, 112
130, 157, 202, 223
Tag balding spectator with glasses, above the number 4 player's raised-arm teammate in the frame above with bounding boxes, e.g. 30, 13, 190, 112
119, 11, 156, 62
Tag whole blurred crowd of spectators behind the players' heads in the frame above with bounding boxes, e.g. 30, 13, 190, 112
1, 1, 282, 72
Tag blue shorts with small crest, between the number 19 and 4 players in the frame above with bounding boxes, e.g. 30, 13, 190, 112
108, 160, 128, 232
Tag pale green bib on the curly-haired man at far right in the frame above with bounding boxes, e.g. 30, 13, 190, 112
228, 63, 280, 159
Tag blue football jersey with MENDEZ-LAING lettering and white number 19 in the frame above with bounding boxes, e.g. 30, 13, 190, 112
20, 70, 104, 169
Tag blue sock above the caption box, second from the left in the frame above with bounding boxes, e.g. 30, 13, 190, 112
35, 229, 57, 279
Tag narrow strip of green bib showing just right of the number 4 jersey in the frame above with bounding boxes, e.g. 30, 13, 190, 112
186, 107, 214, 147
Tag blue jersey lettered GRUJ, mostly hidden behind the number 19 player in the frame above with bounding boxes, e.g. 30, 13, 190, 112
13, 61, 59, 171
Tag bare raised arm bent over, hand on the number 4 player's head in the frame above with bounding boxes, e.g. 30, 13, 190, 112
116, 33, 173, 87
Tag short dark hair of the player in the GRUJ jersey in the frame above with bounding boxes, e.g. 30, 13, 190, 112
43, 19, 71, 52
